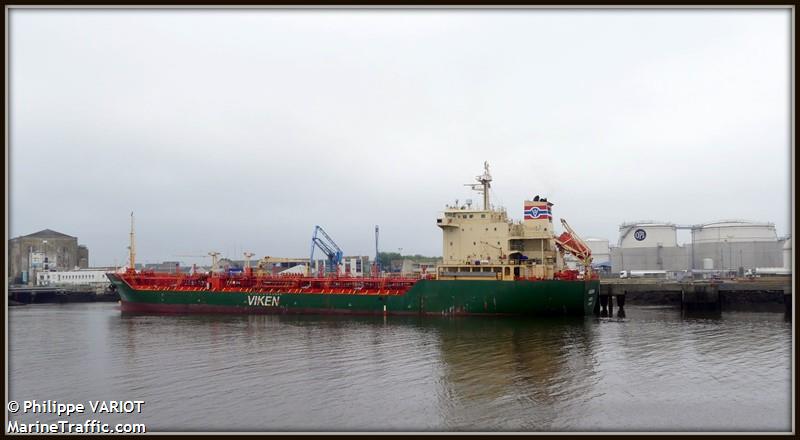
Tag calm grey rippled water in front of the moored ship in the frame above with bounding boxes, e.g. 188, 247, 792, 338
8, 303, 792, 431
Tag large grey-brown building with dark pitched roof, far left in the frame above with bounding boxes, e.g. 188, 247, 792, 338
8, 229, 89, 285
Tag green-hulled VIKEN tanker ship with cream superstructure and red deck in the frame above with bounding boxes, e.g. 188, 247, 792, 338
108, 163, 599, 316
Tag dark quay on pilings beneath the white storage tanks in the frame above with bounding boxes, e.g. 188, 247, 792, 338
595, 277, 793, 317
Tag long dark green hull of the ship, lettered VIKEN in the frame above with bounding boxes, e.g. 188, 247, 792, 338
109, 275, 600, 316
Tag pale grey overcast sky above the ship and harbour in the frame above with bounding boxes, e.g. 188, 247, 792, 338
8, 9, 791, 265
